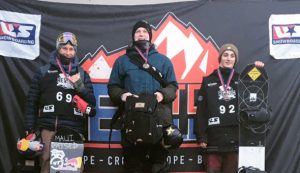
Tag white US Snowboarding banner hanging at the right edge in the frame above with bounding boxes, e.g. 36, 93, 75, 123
269, 14, 300, 59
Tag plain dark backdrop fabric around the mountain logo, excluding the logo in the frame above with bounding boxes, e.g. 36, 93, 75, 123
0, 0, 300, 173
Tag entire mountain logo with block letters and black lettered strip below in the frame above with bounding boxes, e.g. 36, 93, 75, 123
81, 12, 218, 172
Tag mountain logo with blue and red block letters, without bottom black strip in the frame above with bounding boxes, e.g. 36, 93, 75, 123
81, 12, 218, 142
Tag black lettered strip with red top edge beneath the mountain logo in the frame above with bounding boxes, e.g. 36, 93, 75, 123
83, 143, 204, 173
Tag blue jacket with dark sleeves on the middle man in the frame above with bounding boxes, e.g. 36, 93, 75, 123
108, 45, 178, 126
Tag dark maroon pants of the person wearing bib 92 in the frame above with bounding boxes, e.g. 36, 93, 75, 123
204, 152, 238, 173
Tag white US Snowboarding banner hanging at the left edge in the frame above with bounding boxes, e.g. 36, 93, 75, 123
0, 10, 41, 60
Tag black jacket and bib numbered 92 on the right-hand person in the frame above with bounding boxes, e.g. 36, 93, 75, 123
194, 68, 239, 149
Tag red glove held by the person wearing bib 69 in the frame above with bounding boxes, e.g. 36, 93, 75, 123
73, 95, 96, 117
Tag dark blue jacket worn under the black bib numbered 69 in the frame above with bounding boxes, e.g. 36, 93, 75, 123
25, 51, 96, 133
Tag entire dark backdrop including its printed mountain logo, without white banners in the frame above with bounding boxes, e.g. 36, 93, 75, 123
0, 0, 300, 173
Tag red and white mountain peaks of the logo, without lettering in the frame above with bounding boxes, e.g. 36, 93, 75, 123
81, 13, 218, 83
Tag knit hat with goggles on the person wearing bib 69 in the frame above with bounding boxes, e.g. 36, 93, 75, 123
56, 32, 78, 51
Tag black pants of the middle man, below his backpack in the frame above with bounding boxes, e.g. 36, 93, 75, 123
123, 143, 169, 173
